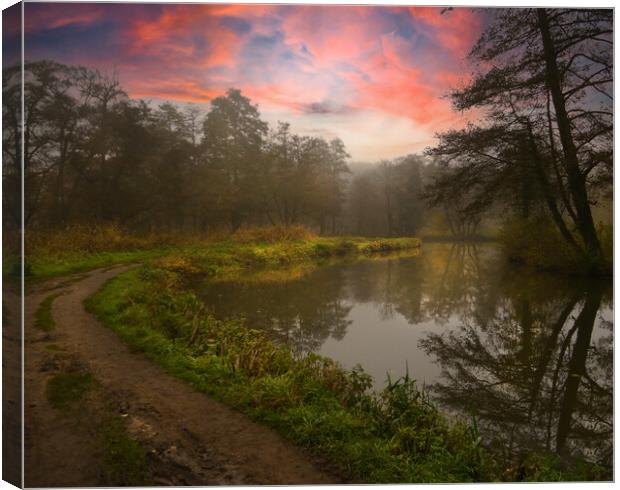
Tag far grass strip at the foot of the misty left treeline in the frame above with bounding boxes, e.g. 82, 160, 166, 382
14, 225, 420, 282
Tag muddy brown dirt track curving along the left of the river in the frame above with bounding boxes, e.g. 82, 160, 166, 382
25, 267, 341, 486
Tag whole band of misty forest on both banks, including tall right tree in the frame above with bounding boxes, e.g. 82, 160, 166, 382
3, 10, 613, 276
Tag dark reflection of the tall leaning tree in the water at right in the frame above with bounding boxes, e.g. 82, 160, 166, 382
420, 245, 613, 466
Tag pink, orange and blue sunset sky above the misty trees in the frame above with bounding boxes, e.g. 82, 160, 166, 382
3, 3, 484, 161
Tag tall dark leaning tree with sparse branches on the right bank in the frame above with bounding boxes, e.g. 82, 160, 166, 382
432, 9, 613, 267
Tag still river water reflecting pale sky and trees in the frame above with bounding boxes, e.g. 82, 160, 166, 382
199, 244, 613, 465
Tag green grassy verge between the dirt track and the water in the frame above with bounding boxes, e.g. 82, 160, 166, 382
86, 260, 600, 483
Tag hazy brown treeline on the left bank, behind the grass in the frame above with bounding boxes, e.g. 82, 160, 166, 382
2, 61, 349, 232
